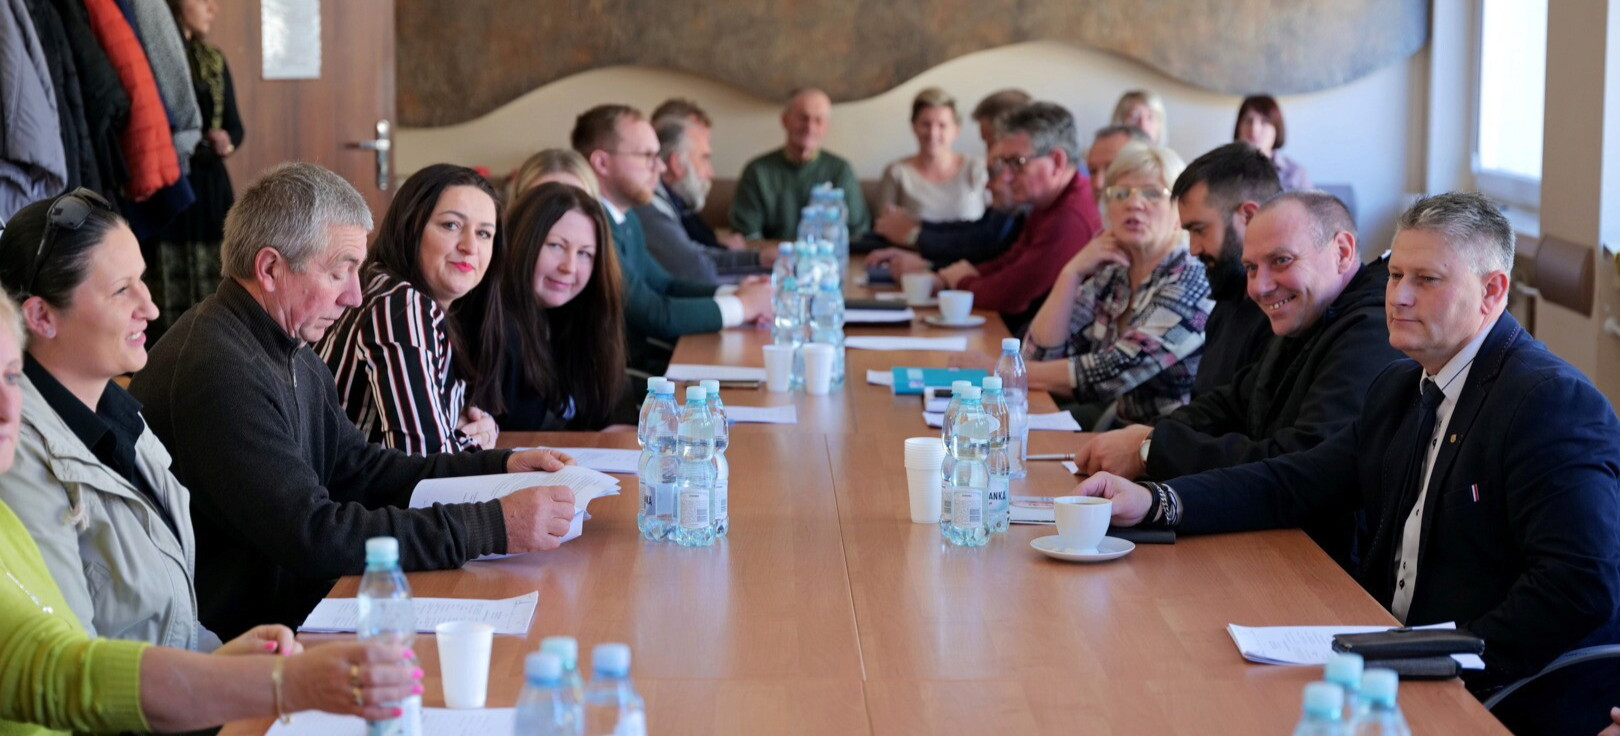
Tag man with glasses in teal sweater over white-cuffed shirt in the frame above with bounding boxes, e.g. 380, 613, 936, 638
570, 105, 771, 376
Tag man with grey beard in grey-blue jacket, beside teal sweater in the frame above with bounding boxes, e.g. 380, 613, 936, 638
633, 115, 766, 285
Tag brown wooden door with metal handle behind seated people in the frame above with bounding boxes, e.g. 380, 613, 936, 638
211, 0, 394, 222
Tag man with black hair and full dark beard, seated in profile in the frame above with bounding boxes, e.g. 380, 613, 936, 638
1179, 142, 1283, 399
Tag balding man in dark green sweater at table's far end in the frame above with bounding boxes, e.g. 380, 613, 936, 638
731, 88, 872, 240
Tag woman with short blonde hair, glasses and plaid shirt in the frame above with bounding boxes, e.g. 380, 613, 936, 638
1024, 143, 1215, 430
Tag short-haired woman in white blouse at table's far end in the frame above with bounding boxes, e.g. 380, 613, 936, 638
878, 88, 988, 222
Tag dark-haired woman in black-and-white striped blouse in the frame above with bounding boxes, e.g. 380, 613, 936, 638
316, 164, 504, 456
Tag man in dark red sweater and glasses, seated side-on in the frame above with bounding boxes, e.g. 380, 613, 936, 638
935, 102, 1102, 334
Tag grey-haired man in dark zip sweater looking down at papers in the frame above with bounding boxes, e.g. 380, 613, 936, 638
130, 164, 573, 639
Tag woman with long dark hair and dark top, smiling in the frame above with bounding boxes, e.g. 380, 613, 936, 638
499, 182, 625, 431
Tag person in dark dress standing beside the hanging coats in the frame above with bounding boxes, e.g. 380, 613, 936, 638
146, 0, 243, 340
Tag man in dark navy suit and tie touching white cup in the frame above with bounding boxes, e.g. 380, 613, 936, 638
1079, 193, 1620, 694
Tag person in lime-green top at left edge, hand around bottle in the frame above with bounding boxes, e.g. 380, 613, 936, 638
0, 283, 421, 736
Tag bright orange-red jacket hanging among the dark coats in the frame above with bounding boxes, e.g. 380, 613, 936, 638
84, 0, 180, 201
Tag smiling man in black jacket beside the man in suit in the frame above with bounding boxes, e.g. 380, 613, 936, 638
1074, 191, 1401, 564
